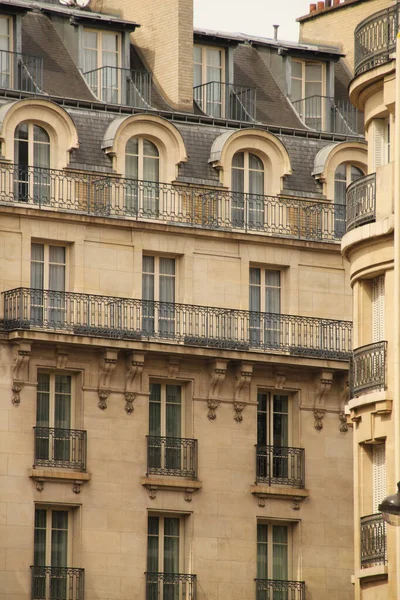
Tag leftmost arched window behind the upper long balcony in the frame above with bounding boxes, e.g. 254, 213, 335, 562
14, 121, 51, 204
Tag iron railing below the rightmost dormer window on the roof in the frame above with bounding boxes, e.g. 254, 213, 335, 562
293, 96, 364, 135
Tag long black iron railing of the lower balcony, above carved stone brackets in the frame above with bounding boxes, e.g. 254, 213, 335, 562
3, 288, 352, 360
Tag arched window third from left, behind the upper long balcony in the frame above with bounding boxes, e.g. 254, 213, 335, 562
232, 150, 265, 229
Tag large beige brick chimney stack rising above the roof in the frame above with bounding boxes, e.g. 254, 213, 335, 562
98, 0, 193, 111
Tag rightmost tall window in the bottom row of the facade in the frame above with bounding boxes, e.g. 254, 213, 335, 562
257, 523, 290, 600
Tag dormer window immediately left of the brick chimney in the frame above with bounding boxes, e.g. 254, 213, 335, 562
82, 29, 121, 104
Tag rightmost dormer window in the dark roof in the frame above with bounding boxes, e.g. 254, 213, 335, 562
290, 60, 325, 130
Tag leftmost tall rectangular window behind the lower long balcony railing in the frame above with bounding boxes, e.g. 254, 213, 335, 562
31, 243, 66, 327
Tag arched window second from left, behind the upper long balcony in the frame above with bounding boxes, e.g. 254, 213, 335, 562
125, 137, 160, 217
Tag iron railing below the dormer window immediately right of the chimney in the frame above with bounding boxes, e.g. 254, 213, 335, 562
193, 81, 256, 121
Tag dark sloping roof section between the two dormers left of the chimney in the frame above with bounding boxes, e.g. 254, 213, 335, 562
22, 12, 95, 100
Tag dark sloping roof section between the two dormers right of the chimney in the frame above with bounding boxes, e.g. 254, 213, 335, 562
234, 44, 304, 129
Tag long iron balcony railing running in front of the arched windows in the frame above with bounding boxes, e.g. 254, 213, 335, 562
0, 164, 346, 242
